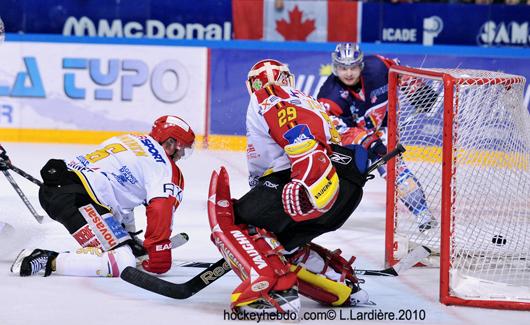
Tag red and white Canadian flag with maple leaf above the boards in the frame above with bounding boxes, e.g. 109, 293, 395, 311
232, 0, 362, 42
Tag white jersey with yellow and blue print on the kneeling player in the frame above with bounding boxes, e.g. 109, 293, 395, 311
66, 134, 184, 225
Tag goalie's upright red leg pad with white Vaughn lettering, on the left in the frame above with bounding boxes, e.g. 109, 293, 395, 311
208, 168, 297, 311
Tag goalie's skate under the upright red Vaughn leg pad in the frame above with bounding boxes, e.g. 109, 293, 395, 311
237, 288, 300, 317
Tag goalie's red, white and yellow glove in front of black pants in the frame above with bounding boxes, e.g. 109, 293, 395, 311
282, 139, 339, 222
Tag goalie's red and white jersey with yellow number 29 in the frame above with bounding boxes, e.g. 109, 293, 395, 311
246, 85, 340, 187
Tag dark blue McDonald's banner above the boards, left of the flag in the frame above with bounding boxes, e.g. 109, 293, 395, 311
0, 0, 232, 40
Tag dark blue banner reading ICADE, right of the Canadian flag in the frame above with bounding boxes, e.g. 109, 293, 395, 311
362, 3, 530, 47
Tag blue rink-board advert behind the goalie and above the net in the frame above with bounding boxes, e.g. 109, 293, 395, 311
210, 49, 530, 135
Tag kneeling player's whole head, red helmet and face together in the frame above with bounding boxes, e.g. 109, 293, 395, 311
149, 115, 195, 161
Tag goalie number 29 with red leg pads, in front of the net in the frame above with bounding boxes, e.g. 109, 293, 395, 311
208, 60, 368, 313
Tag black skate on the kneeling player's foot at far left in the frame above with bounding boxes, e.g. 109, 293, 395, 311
11, 248, 59, 276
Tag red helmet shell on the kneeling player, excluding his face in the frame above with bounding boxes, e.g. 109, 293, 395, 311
149, 115, 195, 148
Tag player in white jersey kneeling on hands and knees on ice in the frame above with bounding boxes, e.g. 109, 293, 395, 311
11, 116, 195, 277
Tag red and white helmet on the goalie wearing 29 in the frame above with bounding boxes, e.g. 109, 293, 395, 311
247, 59, 294, 94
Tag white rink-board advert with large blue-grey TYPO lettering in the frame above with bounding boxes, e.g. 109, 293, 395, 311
0, 42, 207, 134
